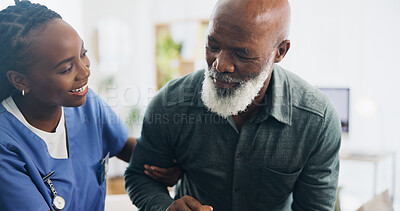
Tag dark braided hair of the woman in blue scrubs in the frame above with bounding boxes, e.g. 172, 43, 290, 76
0, 0, 62, 103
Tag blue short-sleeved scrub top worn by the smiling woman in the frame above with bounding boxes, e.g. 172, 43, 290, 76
0, 90, 128, 210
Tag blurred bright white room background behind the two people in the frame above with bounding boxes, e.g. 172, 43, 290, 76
0, 0, 400, 211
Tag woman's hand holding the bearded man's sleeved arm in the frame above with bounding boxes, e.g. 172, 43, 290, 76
144, 160, 182, 186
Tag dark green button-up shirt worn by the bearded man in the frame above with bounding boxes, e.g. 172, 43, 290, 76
125, 66, 341, 211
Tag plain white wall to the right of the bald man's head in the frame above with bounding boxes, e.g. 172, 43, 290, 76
284, 0, 400, 150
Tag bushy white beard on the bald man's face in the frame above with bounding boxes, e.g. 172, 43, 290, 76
201, 56, 273, 118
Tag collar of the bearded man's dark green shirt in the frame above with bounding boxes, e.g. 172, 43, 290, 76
191, 65, 292, 125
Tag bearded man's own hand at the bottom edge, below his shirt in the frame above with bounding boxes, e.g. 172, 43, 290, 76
166, 195, 213, 211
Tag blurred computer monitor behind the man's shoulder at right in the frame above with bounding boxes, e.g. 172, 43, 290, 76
318, 87, 350, 133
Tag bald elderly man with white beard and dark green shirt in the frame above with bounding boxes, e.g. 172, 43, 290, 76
125, 0, 341, 211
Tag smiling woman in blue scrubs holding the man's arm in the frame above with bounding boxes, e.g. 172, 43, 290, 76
0, 1, 180, 210
